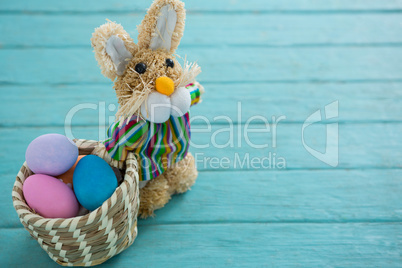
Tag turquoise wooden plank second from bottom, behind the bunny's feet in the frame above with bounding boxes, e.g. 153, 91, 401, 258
0, 169, 402, 228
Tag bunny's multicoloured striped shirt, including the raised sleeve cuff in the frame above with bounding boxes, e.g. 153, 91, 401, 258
104, 83, 200, 181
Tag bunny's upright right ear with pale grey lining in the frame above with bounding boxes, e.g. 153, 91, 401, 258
138, 0, 186, 53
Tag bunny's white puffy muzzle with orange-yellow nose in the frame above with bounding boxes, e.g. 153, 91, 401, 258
141, 76, 191, 123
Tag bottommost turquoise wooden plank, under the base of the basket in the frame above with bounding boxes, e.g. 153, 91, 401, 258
0, 223, 402, 267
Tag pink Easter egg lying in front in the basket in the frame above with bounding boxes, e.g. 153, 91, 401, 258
22, 174, 79, 218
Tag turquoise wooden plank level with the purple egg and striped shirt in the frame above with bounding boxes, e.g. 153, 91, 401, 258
0, 123, 402, 178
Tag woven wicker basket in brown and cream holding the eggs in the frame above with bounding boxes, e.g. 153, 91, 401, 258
12, 140, 139, 266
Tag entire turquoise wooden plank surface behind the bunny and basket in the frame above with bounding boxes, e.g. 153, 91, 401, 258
0, 0, 402, 267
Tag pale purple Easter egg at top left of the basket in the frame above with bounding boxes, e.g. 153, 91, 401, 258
25, 134, 78, 176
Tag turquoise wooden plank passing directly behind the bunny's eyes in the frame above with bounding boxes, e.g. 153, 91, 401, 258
0, 46, 402, 84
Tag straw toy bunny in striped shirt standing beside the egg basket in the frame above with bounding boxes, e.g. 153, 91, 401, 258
91, 0, 203, 218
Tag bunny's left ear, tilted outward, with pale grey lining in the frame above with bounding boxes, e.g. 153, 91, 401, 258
91, 22, 137, 80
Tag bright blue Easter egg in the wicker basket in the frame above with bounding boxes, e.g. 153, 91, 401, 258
73, 155, 117, 211
